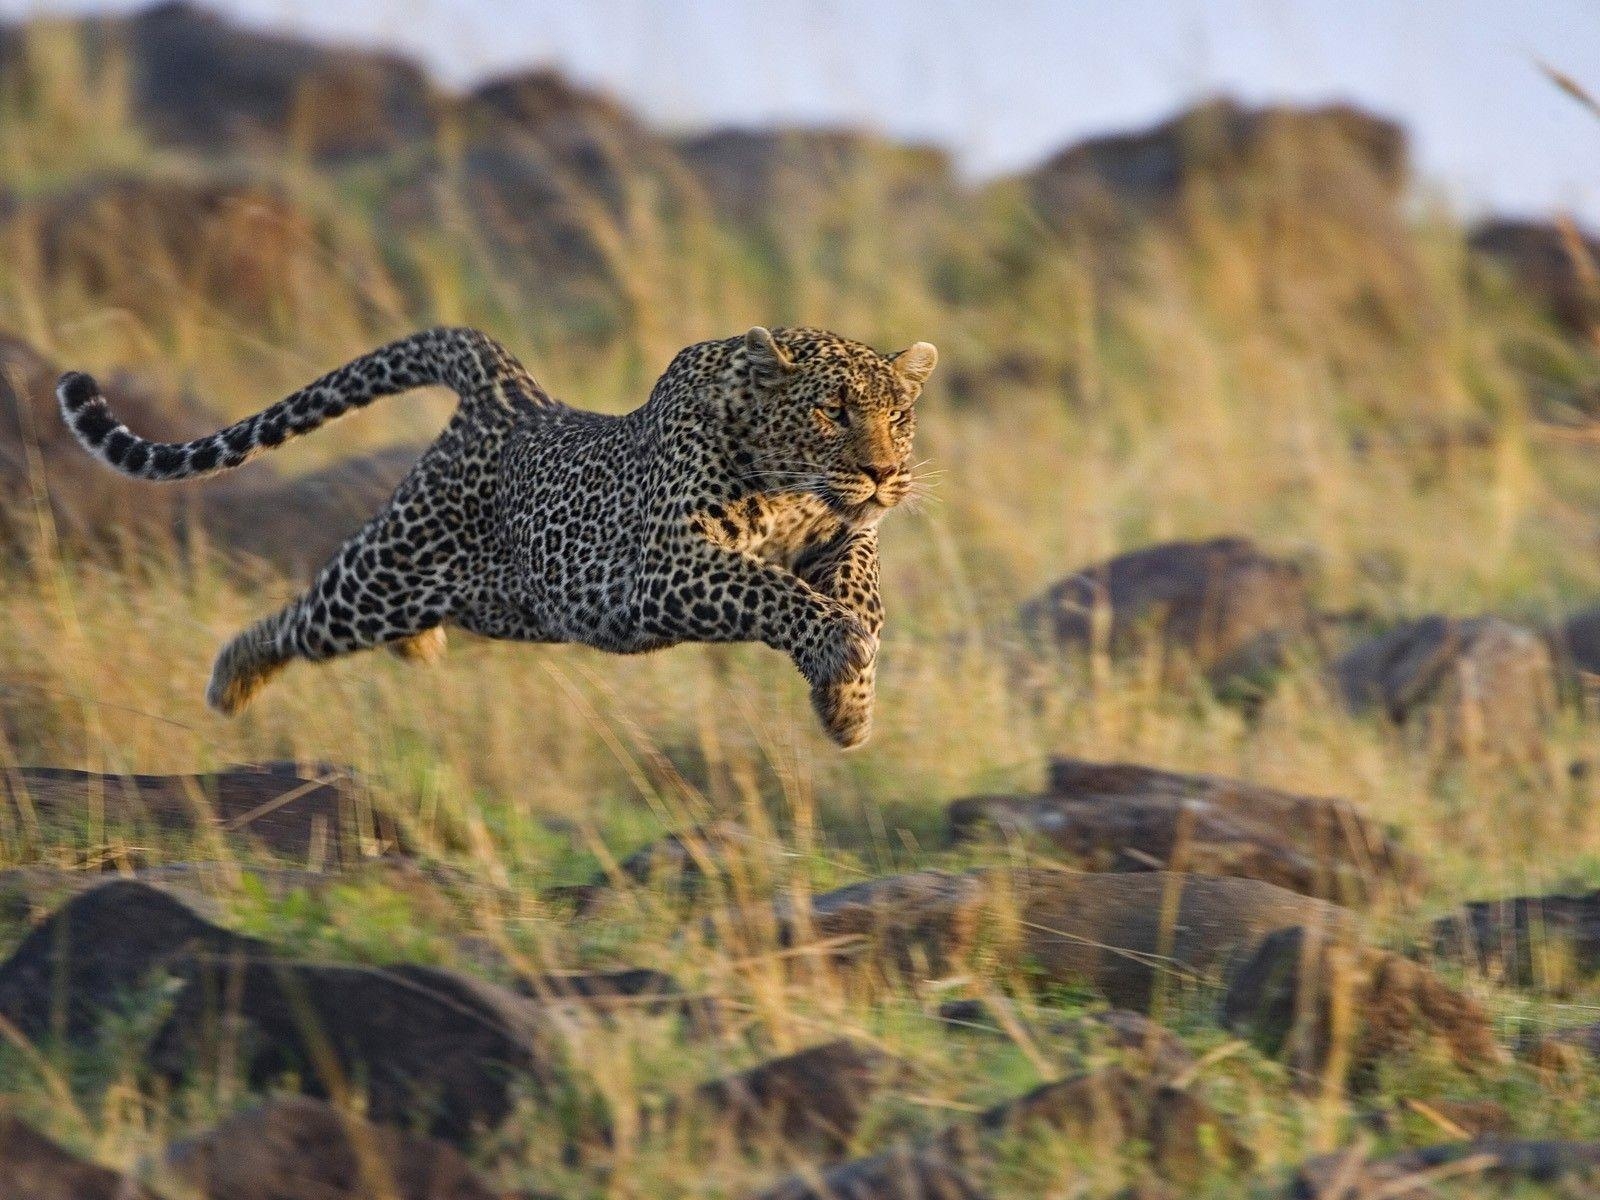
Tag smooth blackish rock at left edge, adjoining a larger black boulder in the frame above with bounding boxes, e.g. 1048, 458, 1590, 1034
0, 880, 264, 1042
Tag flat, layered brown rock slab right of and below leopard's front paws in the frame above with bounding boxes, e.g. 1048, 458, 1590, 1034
947, 758, 1421, 904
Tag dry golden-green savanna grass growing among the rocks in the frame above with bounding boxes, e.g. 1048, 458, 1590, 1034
0, 11, 1600, 1197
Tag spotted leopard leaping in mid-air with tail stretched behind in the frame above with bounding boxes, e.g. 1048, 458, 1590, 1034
56, 325, 938, 749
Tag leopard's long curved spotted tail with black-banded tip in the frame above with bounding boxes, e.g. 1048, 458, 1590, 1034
56, 330, 554, 480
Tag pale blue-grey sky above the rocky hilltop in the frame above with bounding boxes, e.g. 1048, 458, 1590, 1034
0, 0, 1600, 227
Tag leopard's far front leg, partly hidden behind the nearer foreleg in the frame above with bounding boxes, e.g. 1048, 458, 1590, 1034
795, 526, 883, 747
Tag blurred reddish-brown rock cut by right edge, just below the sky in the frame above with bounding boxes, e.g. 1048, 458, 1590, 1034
1467, 218, 1600, 338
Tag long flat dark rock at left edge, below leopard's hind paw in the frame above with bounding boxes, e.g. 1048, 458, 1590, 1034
0, 763, 405, 864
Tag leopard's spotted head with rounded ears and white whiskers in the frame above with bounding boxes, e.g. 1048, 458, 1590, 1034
736, 325, 939, 522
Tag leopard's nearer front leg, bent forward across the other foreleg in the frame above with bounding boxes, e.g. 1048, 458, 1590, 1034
632, 533, 878, 746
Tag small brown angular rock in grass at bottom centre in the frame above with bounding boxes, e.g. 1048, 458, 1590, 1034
694, 1040, 893, 1157
